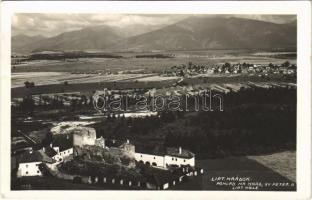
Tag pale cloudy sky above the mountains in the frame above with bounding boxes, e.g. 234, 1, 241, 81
12, 13, 296, 37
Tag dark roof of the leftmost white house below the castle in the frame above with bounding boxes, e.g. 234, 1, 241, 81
17, 150, 53, 163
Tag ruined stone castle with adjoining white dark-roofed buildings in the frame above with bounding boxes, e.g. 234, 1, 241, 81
17, 127, 195, 177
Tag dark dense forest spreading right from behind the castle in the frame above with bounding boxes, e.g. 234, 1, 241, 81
93, 88, 296, 158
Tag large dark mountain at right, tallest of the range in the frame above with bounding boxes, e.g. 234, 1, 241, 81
115, 17, 296, 50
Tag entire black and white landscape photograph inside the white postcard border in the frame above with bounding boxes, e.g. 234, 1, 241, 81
0, 1, 310, 198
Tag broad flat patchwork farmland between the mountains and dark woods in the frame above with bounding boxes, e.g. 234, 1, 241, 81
11, 50, 296, 97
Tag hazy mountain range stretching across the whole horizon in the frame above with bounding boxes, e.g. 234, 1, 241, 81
12, 17, 297, 53
